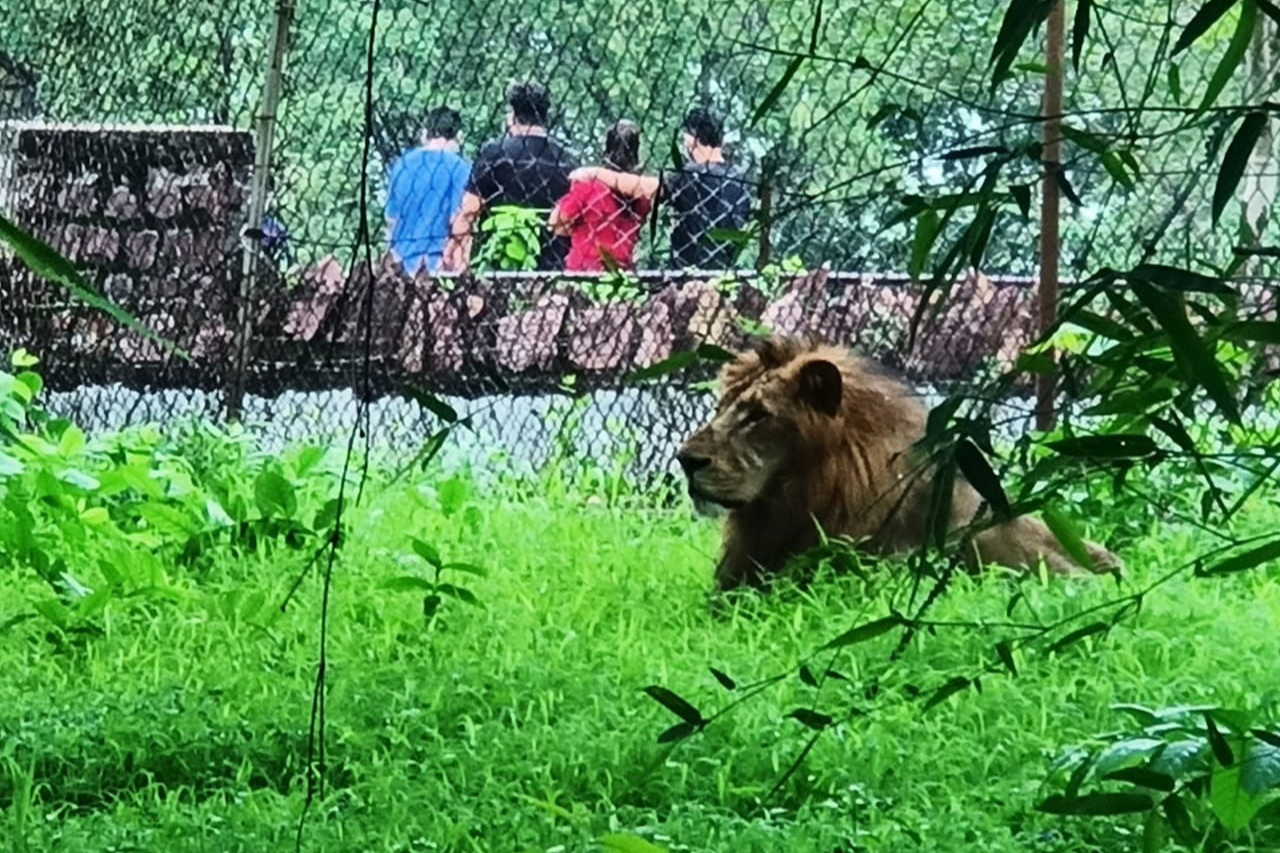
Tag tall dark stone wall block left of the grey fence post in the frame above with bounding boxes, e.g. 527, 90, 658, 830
0, 122, 253, 378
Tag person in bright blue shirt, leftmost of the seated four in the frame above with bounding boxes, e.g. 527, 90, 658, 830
387, 106, 471, 275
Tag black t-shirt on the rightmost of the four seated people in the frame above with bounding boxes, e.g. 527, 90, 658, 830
663, 163, 751, 269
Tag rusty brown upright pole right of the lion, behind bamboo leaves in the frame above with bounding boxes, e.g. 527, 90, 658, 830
1036, 0, 1066, 430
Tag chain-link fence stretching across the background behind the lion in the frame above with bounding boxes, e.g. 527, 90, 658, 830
0, 0, 1277, 465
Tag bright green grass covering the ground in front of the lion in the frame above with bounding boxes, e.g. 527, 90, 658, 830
0, 466, 1280, 853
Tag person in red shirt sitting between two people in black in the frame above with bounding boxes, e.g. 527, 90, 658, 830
549, 120, 653, 273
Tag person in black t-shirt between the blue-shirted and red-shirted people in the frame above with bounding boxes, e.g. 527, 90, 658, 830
444, 83, 577, 272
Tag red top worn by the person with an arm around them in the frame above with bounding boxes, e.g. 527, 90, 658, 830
556, 181, 652, 273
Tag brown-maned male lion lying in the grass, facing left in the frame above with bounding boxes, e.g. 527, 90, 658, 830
676, 337, 1121, 590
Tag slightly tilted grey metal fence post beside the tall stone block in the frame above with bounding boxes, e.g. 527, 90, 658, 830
224, 0, 294, 420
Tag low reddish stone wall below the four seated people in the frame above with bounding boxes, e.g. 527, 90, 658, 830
255, 256, 1036, 396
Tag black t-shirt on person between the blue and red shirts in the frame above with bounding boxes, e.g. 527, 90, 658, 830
467, 136, 577, 270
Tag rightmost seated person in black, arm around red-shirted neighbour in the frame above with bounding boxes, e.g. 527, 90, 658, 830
570, 106, 751, 269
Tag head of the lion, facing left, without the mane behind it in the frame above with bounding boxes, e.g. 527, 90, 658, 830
676, 339, 844, 515
